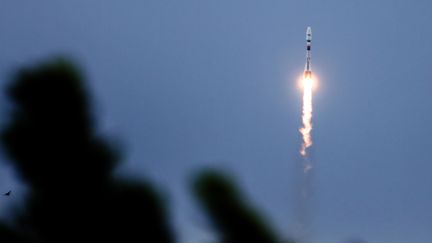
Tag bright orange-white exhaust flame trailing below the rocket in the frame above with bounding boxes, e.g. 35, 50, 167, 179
299, 77, 314, 161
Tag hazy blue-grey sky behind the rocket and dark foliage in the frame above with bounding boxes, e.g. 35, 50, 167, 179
0, 0, 432, 243
